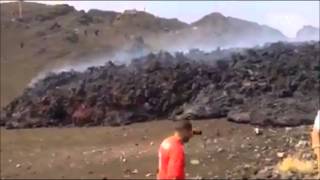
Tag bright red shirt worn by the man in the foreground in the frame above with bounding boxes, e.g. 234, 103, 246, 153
158, 136, 184, 179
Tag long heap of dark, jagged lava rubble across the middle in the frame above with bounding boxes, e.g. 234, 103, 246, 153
1, 42, 320, 128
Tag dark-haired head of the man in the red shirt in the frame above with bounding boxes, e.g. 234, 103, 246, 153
175, 120, 193, 143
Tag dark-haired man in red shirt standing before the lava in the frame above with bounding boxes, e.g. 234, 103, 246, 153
157, 121, 193, 179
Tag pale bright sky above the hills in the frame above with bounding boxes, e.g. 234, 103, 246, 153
3, 0, 320, 37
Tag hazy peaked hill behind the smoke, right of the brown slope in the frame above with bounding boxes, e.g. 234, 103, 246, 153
192, 13, 286, 46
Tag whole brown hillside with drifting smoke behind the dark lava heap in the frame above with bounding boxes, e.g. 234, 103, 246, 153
0, 2, 286, 107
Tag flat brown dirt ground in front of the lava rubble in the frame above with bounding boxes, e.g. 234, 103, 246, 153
1, 119, 316, 179
